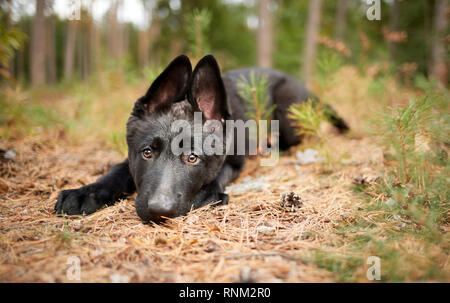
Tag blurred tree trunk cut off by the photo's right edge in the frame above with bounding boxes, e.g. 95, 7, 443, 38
431, 0, 448, 86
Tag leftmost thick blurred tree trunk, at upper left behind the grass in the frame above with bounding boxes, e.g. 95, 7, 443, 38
30, 0, 46, 85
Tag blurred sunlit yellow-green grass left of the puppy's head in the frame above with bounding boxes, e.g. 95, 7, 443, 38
0, 70, 149, 155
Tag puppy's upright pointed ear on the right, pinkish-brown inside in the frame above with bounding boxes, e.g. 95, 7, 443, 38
188, 55, 229, 121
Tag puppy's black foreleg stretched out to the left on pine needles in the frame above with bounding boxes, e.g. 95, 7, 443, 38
55, 160, 136, 215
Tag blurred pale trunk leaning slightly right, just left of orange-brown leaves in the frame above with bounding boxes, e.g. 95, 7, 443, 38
302, 0, 322, 80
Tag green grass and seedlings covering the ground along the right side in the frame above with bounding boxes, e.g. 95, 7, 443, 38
320, 83, 450, 282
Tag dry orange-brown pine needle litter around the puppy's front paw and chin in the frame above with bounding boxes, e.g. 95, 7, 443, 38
0, 132, 377, 282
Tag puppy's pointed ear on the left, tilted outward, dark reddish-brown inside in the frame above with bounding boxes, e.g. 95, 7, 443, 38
140, 55, 192, 112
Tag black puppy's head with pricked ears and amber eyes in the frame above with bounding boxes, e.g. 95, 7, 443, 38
127, 55, 229, 221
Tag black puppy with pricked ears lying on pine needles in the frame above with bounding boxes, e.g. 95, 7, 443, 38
55, 55, 348, 221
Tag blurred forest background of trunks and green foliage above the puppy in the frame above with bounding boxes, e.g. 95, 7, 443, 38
0, 0, 450, 86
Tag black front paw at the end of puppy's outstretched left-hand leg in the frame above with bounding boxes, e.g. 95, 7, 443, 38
55, 184, 111, 215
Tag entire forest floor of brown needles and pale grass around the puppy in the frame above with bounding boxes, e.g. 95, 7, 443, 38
0, 66, 450, 282
